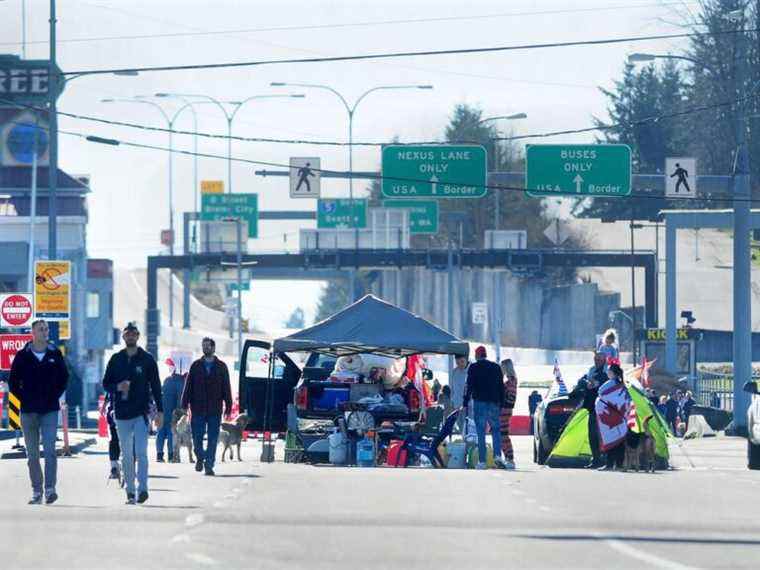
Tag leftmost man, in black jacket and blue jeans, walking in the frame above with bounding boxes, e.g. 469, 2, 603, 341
8, 320, 69, 505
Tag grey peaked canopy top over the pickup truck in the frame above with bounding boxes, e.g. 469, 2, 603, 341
273, 295, 469, 358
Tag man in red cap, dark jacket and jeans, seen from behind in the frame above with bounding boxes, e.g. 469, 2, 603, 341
462, 346, 506, 469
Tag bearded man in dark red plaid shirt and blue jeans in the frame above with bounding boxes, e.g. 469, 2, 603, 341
182, 337, 232, 476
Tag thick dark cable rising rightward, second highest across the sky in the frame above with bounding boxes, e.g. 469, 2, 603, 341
62, 28, 760, 76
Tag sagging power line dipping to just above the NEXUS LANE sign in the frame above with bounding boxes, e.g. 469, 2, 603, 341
0, 89, 759, 147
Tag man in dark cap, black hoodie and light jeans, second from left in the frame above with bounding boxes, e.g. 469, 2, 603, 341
103, 323, 163, 505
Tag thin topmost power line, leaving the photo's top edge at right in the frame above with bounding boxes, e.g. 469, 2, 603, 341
0, 1, 700, 46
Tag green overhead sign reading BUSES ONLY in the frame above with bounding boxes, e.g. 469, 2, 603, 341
525, 144, 632, 197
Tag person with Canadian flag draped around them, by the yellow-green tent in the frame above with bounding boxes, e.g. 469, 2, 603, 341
596, 359, 633, 471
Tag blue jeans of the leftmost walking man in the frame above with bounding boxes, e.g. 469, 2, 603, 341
21, 404, 58, 495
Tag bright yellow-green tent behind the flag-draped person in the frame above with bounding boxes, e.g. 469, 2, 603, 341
546, 386, 669, 468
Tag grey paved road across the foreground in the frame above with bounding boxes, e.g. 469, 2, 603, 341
0, 432, 760, 570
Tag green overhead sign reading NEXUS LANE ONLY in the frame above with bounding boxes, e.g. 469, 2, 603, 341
382, 144, 486, 198
